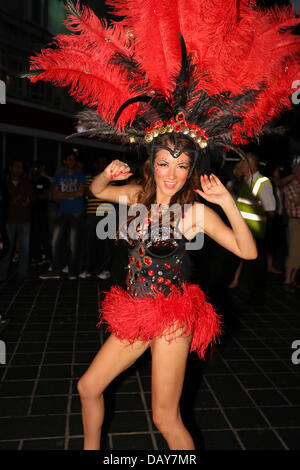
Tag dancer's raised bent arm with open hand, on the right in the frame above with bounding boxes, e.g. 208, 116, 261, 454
195, 174, 257, 259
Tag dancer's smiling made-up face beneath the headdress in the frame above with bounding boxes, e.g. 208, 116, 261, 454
154, 144, 191, 204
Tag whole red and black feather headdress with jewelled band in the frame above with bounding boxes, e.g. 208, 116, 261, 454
25, 0, 300, 162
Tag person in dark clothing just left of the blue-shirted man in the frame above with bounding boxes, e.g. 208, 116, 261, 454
31, 162, 51, 262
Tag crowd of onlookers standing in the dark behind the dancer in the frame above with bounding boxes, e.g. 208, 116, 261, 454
0, 147, 300, 310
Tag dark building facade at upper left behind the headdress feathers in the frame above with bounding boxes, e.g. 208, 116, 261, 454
0, 0, 123, 174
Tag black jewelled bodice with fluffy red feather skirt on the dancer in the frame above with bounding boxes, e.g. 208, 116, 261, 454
99, 225, 221, 359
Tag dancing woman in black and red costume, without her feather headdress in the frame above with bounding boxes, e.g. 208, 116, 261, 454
78, 131, 257, 449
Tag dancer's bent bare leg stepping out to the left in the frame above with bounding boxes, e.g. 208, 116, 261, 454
77, 335, 149, 450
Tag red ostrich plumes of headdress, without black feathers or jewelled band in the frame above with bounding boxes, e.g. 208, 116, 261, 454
27, 0, 300, 144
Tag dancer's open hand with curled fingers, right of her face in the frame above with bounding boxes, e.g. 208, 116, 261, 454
194, 173, 233, 206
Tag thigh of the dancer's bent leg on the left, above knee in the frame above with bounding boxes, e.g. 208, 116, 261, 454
80, 334, 149, 394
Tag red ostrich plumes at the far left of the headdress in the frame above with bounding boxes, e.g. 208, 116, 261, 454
30, 4, 138, 128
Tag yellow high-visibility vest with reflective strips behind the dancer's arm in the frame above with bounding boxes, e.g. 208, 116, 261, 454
236, 175, 272, 238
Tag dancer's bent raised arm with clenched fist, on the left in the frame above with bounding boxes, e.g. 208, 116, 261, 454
90, 160, 142, 205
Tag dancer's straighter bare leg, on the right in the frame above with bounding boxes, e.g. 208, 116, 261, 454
151, 328, 195, 450
